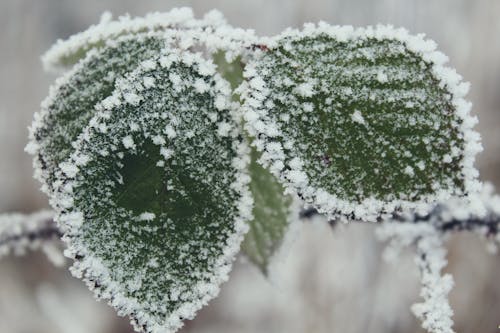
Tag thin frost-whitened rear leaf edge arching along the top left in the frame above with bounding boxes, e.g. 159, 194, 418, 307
42, 7, 255, 71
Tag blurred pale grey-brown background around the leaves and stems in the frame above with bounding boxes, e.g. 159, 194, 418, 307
0, 0, 500, 333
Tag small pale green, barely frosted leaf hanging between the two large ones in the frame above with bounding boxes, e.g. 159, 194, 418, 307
241, 149, 299, 275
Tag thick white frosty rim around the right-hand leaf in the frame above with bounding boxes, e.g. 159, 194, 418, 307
238, 22, 482, 221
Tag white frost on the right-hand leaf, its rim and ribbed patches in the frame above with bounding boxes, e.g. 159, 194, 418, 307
238, 22, 482, 221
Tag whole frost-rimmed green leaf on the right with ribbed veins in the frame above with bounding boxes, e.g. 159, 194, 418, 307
240, 23, 481, 221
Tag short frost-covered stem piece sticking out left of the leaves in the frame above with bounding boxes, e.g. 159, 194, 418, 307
0, 210, 62, 264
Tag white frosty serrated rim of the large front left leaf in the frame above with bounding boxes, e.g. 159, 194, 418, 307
51, 49, 253, 333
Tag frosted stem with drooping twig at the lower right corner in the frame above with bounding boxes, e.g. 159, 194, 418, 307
377, 184, 500, 333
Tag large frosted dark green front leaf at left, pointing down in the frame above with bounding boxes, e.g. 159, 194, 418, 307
53, 50, 252, 332
